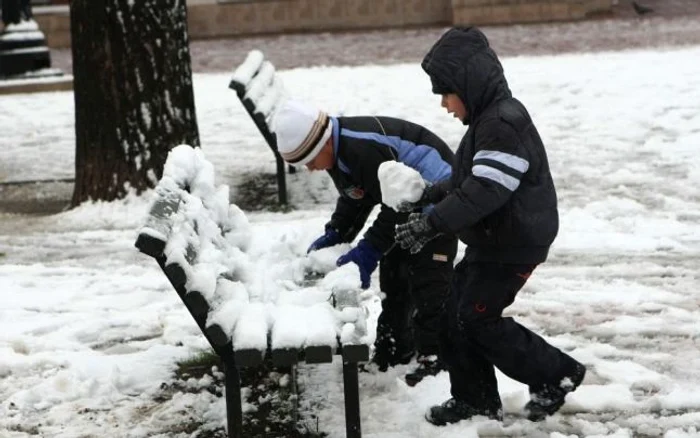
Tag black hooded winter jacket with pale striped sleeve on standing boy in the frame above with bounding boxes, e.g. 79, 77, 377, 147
422, 27, 559, 264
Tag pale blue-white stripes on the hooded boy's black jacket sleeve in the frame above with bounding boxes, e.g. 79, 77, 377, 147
472, 150, 530, 192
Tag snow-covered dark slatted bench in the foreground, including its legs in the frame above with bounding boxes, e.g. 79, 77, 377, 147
136, 145, 369, 437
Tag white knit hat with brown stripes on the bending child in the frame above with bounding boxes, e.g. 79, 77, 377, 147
272, 99, 332, 166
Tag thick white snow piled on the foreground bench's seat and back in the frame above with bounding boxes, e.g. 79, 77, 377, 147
140, 145, 372, 362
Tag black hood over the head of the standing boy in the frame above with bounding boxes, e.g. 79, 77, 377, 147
421, 27, 512, 125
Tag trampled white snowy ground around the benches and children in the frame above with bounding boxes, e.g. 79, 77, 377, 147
0, 42, 700, 438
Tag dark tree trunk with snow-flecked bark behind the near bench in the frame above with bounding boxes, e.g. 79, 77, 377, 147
70, 0, 199, 206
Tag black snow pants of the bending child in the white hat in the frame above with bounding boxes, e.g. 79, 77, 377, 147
374, 236, 457, 366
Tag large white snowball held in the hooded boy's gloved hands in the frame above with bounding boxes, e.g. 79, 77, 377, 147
377, 161, 425, 211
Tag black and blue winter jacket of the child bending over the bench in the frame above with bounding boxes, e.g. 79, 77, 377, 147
326, 116, 454, 253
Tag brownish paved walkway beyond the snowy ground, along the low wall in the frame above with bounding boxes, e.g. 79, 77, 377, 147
52, 0, 700, 72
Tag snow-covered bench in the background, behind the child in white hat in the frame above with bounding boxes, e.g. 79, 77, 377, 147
229, 50, 294, 208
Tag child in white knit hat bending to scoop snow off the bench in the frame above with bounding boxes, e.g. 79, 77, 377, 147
272, 100, 457, 385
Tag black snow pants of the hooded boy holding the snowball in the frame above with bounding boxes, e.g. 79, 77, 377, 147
440, 260, 578, 412
